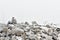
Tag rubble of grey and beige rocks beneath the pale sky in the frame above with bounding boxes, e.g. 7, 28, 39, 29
0, 17, 60, 40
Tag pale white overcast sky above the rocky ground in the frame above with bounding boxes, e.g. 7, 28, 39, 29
0, 0, 60, 23
